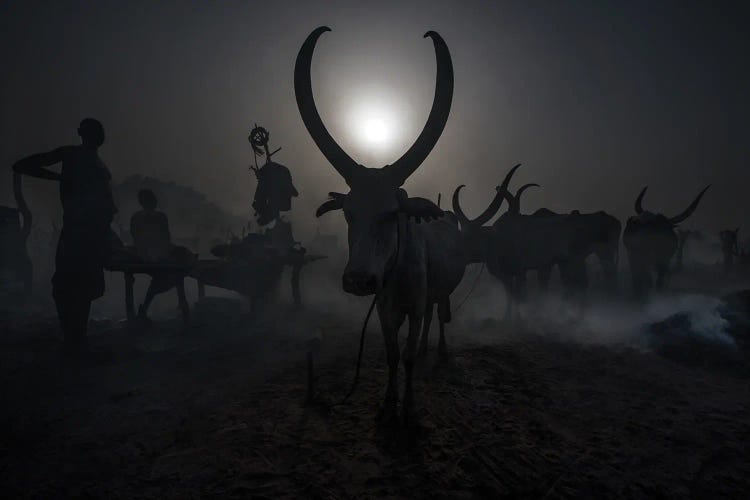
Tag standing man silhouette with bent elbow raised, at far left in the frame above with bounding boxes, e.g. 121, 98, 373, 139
13, 118, 117, 354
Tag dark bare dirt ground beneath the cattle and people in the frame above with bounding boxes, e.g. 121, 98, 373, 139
0, 294, 750, 499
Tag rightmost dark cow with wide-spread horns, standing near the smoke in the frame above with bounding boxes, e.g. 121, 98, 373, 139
622, 185, 711, 297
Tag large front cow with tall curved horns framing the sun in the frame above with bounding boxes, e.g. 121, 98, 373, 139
294, 27, 465, 423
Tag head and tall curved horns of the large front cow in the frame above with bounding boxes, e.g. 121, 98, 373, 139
294, 27, 453, 295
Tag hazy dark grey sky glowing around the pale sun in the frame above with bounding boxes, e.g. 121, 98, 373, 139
0, 0, 750, 242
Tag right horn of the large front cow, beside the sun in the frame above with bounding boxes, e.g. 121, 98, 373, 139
388, 31, 453, 186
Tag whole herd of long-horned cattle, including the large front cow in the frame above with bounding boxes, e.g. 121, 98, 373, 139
294, 27, 708, 421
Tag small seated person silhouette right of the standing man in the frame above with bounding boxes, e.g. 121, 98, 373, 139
130, 189, 195, 320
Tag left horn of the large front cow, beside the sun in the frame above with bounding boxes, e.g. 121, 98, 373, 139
294, 26, 358, 183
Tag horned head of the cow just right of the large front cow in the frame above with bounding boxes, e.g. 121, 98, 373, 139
453, 163, 538, 263
